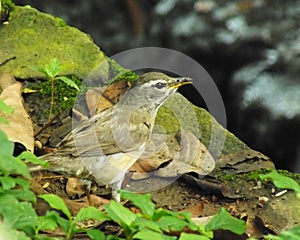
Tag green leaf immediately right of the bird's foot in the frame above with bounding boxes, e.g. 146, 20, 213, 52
120, 190, 155, 218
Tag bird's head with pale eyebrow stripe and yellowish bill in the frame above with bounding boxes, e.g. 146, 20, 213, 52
128, 72, 192, 105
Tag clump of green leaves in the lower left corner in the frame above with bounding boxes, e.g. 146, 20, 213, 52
0, 131, 50, 240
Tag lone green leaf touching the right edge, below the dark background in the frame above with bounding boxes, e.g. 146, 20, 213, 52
259, 170, 300, 196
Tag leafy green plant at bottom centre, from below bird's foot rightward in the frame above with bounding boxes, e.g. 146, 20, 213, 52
101, 191, 246, 240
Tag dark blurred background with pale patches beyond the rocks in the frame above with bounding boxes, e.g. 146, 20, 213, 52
15, 0, 300, 172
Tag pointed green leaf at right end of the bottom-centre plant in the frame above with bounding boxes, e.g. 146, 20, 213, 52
205, 208, 247, 235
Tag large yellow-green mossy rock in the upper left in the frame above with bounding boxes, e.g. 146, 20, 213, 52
0, 7, 106, 79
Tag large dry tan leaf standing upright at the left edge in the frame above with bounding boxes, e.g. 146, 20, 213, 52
0, 74, 34, 152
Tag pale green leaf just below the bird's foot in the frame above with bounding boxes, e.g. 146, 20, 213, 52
104, 201, 136, 228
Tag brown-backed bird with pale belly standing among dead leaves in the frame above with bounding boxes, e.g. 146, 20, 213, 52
41, 72, 192, 201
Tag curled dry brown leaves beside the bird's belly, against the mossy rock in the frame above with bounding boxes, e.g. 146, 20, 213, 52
130, 131, 215, 180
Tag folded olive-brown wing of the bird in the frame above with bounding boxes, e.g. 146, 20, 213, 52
59, 107, 150, 156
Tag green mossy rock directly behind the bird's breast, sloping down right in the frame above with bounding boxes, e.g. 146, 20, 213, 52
156, 93, 250, 157
